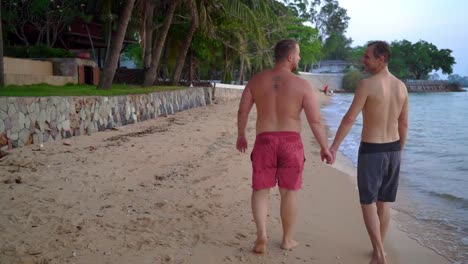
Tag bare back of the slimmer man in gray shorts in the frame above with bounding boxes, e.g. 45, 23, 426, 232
361, 74, 408, 143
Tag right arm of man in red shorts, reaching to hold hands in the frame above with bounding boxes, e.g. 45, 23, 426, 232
302, 82, 333, 164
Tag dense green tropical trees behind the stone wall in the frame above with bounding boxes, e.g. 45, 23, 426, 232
0, 0, 350, 89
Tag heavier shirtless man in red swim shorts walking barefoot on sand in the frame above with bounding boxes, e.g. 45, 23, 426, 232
237, 39, 332, 253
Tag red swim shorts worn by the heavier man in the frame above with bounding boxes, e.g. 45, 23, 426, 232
250, 131, 305, 190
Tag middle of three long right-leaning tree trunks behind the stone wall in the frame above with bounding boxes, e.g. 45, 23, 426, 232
143, 0, 179, 87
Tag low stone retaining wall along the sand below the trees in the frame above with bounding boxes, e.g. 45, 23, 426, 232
0, 88, 216, 150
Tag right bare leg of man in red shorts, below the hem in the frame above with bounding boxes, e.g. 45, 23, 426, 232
279, 188, 298, 250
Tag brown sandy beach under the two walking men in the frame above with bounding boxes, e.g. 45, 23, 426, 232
0, 92, 450, 264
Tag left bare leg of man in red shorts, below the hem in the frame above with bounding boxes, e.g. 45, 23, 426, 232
252, 189, 270, 253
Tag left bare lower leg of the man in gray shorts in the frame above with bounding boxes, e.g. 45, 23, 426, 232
361, 203, 387, 264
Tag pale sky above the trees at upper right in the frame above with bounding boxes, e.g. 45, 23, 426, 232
338, 0, 468, 76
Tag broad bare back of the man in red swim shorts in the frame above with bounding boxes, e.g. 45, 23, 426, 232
248, 69, 311, 134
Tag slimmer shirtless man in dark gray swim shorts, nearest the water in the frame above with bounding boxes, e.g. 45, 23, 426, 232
330, 41, 408, 264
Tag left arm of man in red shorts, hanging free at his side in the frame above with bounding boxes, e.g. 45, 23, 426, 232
236, 83, 254, 152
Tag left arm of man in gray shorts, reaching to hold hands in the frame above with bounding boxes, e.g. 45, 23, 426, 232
330, 81, 367, 155
